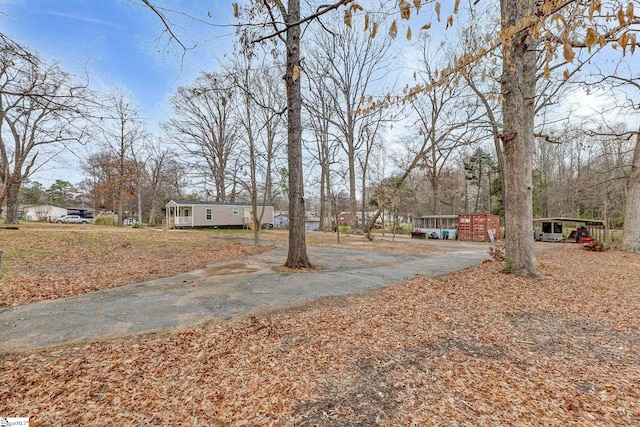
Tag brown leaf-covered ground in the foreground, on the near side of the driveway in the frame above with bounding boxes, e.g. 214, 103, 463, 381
0, 237, 640, 426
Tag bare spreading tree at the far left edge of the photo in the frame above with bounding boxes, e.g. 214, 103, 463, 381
0, 34, 87, 224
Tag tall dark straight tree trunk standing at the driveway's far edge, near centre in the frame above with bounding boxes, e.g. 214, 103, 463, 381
284, 0, 311, 268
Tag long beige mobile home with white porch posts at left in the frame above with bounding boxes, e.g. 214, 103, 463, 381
166, 200, 273, 228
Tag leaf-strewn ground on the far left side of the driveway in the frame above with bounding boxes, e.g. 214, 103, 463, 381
0, 224, 272, 307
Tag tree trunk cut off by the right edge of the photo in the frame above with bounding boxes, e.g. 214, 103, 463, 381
622, 128, 640, 252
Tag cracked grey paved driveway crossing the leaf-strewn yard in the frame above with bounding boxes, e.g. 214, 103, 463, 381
0, 236, 489, 352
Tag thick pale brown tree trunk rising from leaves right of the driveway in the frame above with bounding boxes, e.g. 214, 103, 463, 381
500, 0, 537, 277
